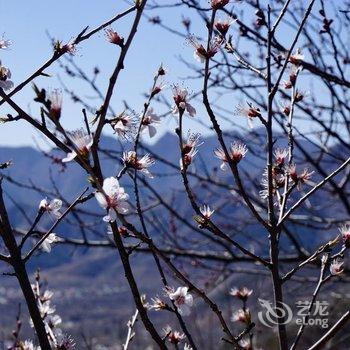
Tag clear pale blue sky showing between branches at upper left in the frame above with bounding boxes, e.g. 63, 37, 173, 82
0, 0, 212, 146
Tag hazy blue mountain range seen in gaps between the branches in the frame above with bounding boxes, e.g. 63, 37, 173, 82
0, 130, 343, 349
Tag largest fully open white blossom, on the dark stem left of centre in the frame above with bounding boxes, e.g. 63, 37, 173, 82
95, 177, 129, 222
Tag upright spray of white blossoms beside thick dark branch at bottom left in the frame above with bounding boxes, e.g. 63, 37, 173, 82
28, 273, 75, 350
